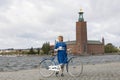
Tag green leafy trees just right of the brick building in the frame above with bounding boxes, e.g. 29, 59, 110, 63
105, 43, 119, 53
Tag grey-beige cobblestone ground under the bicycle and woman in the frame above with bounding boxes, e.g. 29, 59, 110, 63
0, 62, 120, 80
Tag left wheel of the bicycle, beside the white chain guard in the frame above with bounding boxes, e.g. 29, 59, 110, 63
39, 59, 55, 77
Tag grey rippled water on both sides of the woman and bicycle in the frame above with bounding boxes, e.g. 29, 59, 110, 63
0, 55, 120, 72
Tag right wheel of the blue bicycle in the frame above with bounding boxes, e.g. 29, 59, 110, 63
67, 57, 83, 77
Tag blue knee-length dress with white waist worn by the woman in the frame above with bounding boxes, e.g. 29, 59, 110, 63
55, 42, 67, 64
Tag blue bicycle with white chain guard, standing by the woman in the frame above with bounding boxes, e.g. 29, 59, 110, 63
40, 55, 83, 77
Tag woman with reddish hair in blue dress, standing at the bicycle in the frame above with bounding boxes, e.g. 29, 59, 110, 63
55, 36, 67, 76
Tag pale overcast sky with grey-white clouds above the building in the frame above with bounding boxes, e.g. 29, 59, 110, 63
0, 0, 120, 49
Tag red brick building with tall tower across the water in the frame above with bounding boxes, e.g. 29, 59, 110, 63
66, 11, 104, 55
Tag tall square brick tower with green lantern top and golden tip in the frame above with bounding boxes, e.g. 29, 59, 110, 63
76, 9, 87, 54
